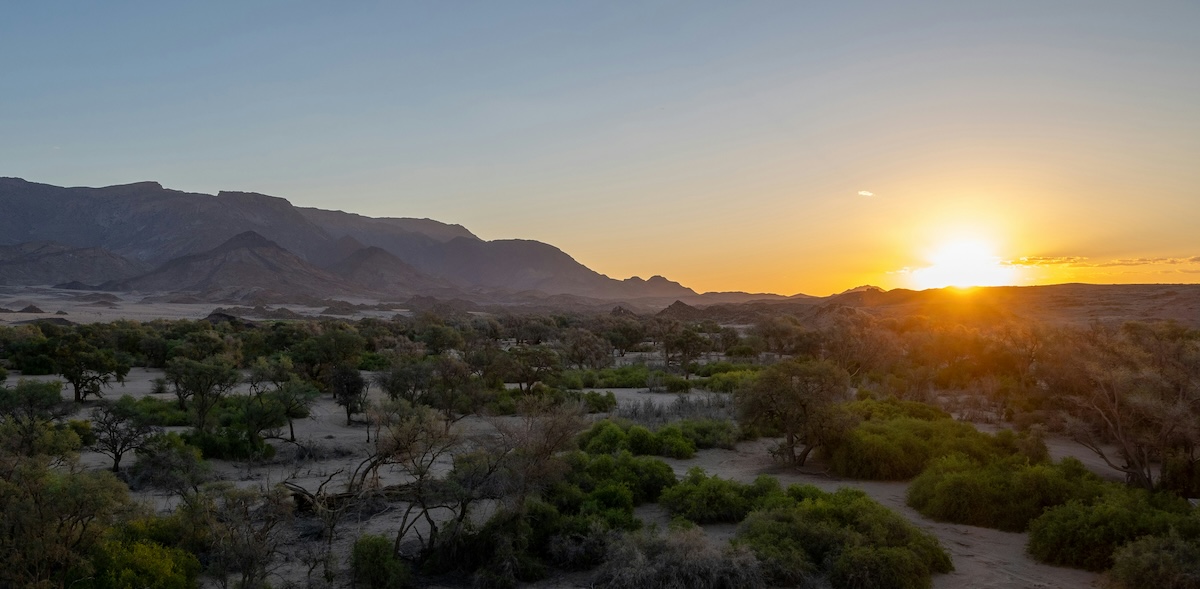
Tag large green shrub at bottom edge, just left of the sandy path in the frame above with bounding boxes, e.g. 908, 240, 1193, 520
734, 486, 953, 588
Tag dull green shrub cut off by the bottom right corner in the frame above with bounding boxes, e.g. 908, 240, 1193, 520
1110, 533, 1200, 589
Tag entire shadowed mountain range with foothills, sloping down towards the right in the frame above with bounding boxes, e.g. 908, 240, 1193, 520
0, 178, 786, 306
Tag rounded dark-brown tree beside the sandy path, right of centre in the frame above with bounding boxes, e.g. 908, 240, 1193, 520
737, 360, 850, 467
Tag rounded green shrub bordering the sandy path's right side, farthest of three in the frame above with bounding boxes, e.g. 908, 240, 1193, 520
907, 455, 1105, 531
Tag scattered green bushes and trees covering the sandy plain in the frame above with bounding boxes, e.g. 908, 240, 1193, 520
0, 308, 1200, 588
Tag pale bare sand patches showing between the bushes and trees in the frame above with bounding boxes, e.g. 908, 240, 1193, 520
10, 368, 1112, 589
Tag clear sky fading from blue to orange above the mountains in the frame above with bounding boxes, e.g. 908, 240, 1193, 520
0, 0, 1200, 295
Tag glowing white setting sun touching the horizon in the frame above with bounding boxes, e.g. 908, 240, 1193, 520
911, 241, 1016, 289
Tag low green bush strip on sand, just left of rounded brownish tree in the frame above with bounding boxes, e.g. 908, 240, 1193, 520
578, 419, 739, 458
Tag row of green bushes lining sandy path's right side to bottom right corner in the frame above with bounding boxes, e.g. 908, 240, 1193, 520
907, 436, 1200, 588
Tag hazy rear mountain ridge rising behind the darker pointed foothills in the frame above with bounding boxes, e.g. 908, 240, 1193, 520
0, 178, 696, 300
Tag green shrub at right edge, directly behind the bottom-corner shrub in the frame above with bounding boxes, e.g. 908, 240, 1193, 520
1027, 485, 1200, 571
